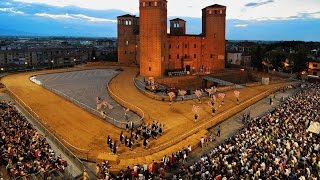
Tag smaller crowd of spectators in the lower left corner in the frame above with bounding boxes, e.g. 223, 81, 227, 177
0, 102, 68, 178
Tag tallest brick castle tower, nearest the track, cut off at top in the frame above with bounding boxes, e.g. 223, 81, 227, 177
139, 0, 167, 77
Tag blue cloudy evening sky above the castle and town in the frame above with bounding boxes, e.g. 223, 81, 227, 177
0, 0, 320, 41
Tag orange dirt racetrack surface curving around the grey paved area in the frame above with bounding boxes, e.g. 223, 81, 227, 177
2, 68, 292, 170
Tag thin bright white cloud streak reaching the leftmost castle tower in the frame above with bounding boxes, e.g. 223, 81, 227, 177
34, 13, 117, 23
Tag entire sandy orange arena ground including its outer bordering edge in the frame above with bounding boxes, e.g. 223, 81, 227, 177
2, 67, 292, 171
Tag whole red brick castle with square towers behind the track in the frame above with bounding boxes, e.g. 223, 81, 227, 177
118, 0, 226, 77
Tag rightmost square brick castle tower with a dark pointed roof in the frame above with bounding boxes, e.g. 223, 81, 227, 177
202, 4, 226, 70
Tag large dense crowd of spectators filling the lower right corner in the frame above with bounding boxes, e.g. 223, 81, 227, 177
178, 85, 320, 180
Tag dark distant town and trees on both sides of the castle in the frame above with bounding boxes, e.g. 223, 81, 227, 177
0, 37, 320, 80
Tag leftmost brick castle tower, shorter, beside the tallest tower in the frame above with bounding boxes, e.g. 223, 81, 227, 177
118, 14, 139, 64
